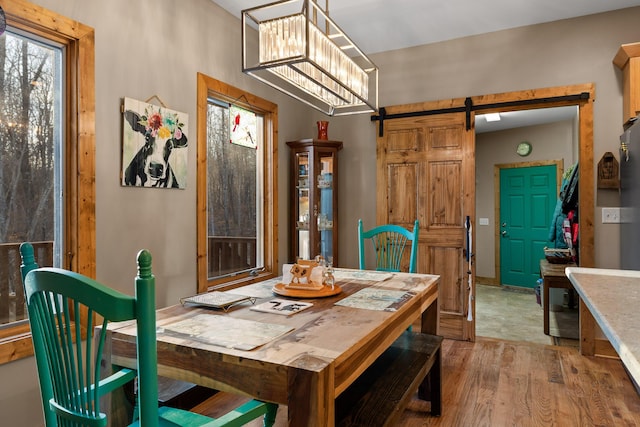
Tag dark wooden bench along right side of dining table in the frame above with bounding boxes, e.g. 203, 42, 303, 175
336, 331, 442, 427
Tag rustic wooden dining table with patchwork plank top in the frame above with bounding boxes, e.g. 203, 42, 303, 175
105, 269, 439, 427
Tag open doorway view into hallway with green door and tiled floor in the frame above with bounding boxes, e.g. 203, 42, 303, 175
476, 107, 579, 341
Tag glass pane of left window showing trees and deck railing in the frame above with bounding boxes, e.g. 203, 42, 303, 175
0, 31, 63, 324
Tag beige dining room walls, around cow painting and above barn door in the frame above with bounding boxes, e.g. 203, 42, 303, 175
0, 0, 640, 426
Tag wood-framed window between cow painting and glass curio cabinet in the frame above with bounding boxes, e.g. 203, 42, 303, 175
197, 74, 278, 292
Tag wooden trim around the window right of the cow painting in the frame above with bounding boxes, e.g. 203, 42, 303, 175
197, 73, 278, 293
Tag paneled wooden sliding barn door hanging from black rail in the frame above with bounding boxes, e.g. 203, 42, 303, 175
377, 111, 475, 341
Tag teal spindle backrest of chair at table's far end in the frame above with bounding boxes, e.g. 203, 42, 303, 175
358, 219, 419, 273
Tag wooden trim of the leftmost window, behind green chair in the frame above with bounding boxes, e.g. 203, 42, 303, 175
0, 0, 96, 364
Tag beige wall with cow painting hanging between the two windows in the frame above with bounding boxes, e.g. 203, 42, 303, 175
0, 0, 316, 426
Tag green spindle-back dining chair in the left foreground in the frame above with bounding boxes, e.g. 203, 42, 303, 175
20, 243, 277, 427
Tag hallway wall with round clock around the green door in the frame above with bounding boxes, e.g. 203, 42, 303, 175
474, 120, 575, 283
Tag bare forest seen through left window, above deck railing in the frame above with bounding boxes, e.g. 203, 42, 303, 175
0, 33, 62, 247
